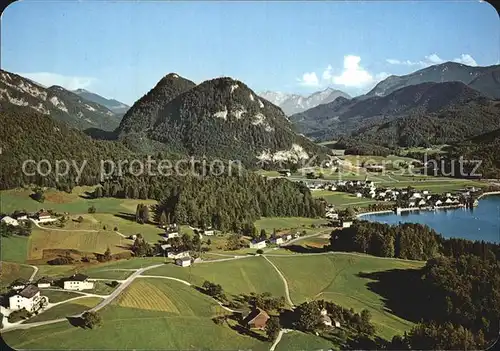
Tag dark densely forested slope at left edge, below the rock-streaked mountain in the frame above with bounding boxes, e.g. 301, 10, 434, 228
0, 106, 130, 190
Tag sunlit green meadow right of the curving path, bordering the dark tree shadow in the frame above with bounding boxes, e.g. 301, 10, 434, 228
269, 253, 424, 338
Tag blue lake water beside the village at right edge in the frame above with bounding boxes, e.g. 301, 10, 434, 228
360, 195, 500, 243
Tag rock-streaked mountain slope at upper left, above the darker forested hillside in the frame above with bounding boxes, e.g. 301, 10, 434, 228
0, 70, 120, 131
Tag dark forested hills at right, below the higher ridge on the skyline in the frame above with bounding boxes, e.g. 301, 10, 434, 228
291, 82, 500, 146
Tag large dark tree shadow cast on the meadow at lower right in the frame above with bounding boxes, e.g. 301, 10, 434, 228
357, 269, 429, 322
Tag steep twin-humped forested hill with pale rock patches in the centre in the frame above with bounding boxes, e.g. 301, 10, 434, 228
119, 76, 324, 164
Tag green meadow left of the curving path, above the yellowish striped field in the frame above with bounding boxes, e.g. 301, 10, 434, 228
145, 257, 285, 297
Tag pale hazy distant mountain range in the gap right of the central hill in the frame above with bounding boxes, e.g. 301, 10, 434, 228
259, 88, 350, 116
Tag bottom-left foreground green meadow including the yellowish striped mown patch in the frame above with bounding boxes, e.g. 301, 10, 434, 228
2, 278, 270, 351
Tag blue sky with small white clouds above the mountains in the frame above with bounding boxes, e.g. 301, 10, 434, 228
0, 0, 500, 104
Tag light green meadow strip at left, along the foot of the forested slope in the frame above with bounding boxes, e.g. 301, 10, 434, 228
0, 187, 156, 214
